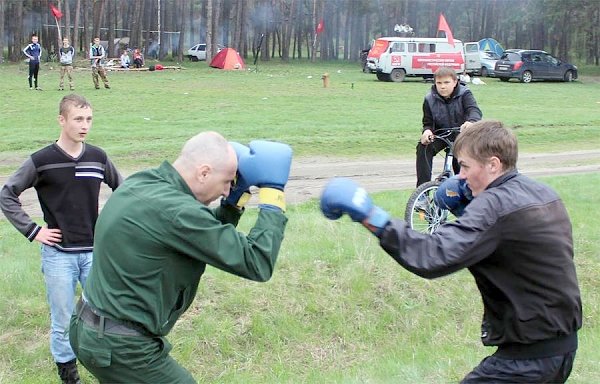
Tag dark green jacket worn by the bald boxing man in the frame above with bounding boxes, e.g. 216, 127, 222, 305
84, 162, 287, 336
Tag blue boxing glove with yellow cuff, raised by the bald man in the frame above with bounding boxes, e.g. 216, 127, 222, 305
239, 140, 292, 211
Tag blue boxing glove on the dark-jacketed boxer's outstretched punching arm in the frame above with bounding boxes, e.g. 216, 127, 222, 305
321, 178, 390, 236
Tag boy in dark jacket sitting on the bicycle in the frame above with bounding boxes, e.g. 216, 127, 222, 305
416, 67, 482, 187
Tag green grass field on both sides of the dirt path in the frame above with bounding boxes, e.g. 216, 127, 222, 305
0, 62, 600, 384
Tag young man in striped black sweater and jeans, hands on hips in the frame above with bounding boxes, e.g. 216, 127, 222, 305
0, 94, 122, 384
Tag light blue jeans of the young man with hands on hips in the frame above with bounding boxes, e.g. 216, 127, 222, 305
42, 244, 93, 363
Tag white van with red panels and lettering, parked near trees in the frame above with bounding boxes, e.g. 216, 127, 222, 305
367, 37, 480, 82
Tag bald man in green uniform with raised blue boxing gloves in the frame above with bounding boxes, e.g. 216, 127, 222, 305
70, 132, 292, 383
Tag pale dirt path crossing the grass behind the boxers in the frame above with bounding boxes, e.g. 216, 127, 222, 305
0, 150, 600, 218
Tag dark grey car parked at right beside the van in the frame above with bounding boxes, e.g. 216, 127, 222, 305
494, 49, 577, 83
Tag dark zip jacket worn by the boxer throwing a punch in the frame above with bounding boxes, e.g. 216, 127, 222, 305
380, 171, 582, 358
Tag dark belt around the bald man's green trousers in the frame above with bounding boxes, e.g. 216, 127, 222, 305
75, 299, 149, 338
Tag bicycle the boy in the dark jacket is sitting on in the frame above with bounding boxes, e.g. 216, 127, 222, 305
404, 127, 460, 234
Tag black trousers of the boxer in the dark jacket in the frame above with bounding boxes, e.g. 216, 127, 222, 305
461, 351, 575, 384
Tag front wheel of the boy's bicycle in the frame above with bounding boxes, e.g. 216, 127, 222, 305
404, 180, 454, 234
